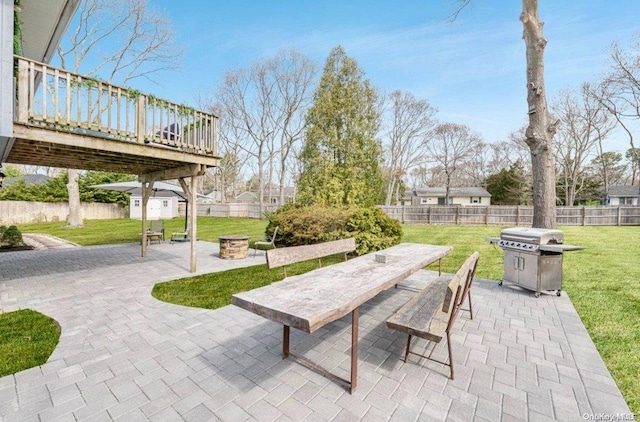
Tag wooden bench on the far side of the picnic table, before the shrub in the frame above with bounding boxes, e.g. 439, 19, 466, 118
267, 237, 356, 277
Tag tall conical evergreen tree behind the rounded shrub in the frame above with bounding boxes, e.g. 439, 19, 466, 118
298, 46, 382, 206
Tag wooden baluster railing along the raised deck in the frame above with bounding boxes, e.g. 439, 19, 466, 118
15, 56, 217, 156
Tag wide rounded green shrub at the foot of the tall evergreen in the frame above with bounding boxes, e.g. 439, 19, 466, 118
265, 205, 402, 255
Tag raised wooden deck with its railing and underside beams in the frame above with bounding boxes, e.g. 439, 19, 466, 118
0, 57, 220, 180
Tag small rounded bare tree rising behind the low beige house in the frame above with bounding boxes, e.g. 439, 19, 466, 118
425, 123, 482, 204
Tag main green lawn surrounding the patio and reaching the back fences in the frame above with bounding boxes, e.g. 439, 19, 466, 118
8, 218, 640, 414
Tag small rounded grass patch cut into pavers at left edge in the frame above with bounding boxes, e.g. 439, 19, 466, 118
0, 309, 60, 377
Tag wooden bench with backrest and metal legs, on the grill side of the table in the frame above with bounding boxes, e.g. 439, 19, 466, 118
387, 252, 480, 379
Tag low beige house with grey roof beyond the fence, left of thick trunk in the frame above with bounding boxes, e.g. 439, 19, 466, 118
403, 187, 491, 206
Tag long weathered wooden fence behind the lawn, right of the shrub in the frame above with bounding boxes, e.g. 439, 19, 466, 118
380, 205, 640, 226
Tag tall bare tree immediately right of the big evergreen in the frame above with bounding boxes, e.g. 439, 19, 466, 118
385, 91, 436, 205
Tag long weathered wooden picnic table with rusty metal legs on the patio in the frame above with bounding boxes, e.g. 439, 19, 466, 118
231, 243, 452, 393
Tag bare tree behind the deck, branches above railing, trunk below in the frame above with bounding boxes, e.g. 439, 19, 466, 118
58, 0, 180, 227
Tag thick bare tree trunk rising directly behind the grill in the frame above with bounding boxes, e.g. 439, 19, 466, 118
520, 0, 556, 229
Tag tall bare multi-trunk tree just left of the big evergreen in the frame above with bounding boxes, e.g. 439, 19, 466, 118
215, 50, 316, 214
